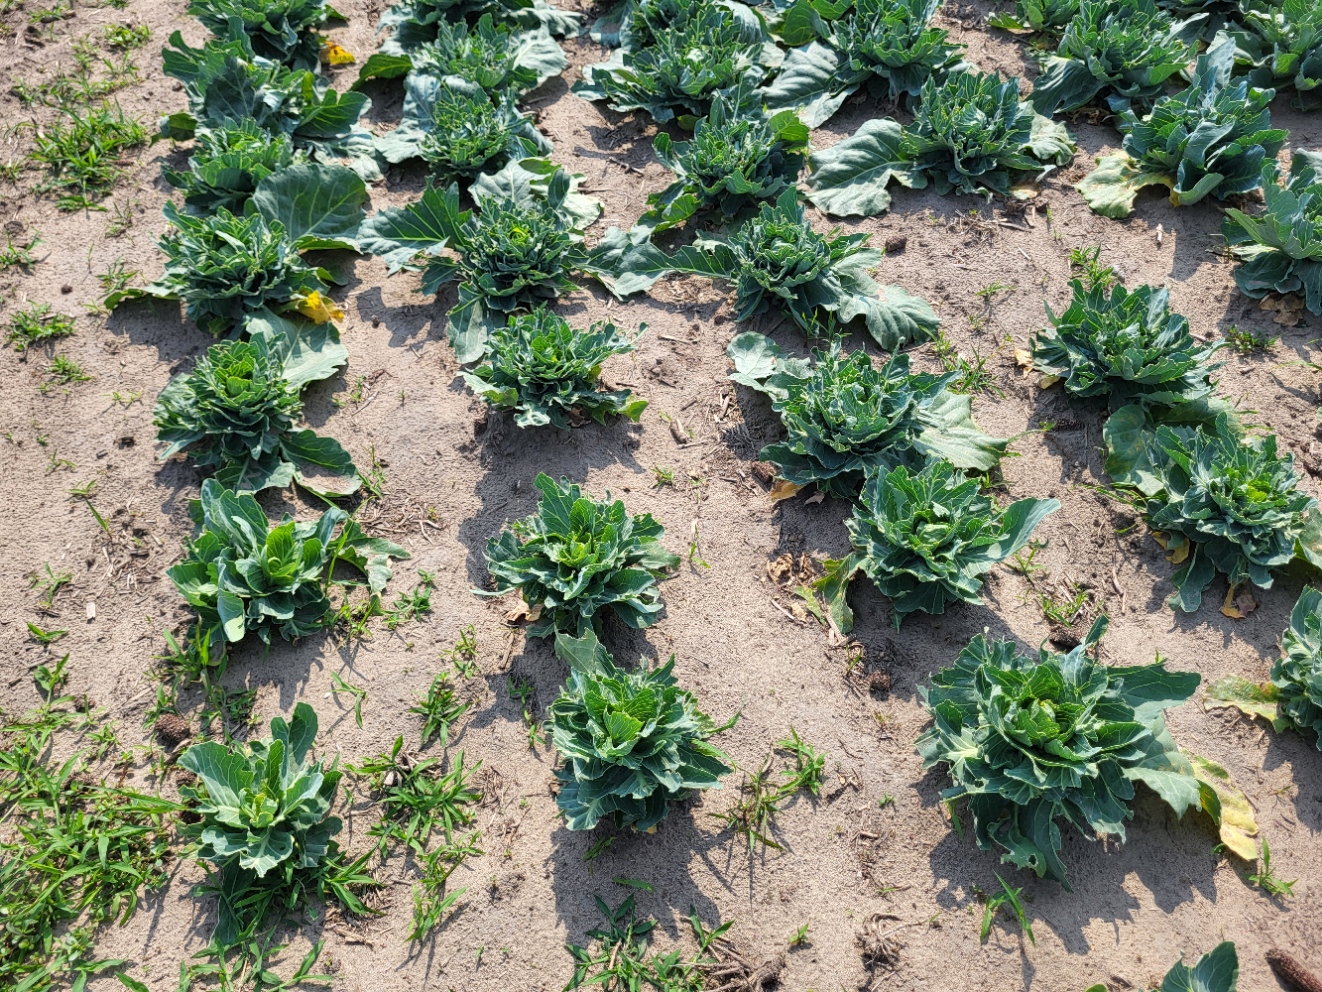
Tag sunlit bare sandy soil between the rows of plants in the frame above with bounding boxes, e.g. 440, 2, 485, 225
0, 0, 1322, 992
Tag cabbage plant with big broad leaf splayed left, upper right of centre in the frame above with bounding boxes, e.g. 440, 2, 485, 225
808, 71, 1075, 216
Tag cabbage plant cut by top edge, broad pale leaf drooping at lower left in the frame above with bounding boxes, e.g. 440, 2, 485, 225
760, 0, 968, 127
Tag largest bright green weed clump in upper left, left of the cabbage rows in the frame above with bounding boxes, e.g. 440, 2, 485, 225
30, 106, 149, 210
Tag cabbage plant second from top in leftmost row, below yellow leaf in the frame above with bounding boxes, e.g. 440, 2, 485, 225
161, 21, 381, 179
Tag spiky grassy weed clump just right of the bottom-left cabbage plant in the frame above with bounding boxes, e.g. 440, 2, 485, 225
348, 737, 483, 857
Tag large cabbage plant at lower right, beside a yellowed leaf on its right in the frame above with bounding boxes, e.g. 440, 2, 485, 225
916, 616, 1202, 891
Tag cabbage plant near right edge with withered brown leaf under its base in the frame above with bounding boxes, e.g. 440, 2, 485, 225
1103, 406, 1317, 612
